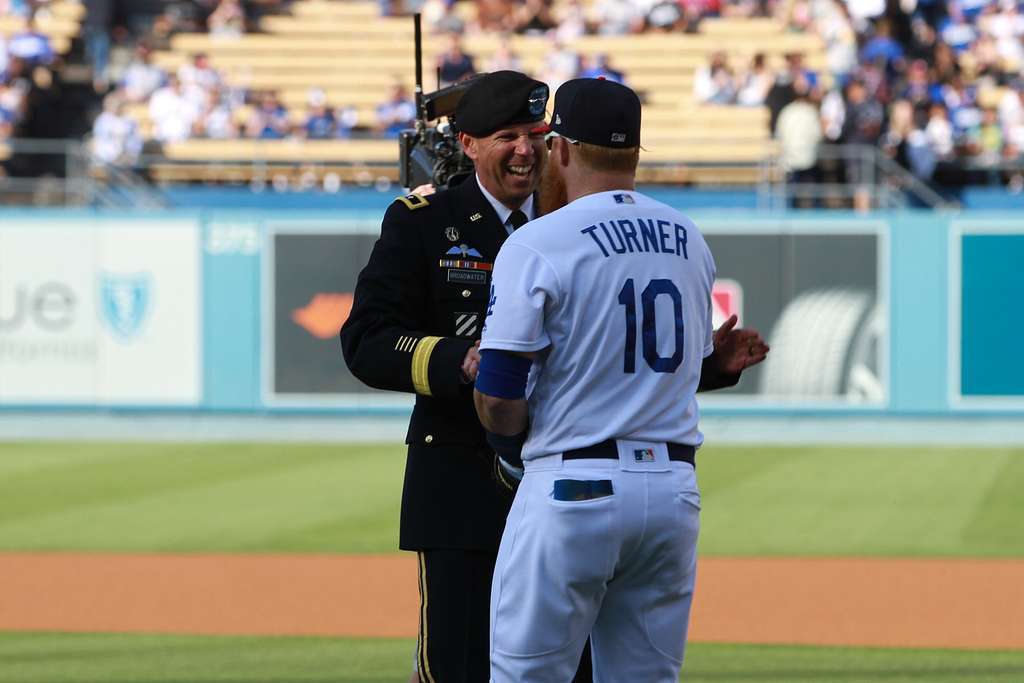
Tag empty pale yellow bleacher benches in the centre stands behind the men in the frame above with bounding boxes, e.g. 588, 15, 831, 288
138, 0, 824, 183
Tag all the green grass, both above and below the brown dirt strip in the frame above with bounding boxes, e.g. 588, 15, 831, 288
0, 443, 1024, 683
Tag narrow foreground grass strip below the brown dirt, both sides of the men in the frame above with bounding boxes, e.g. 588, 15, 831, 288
0, 634, 1024, 683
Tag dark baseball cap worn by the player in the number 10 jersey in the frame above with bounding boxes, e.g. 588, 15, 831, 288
551, 78, 640, 148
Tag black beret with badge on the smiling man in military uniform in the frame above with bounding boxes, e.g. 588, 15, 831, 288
455, 71, 548, 137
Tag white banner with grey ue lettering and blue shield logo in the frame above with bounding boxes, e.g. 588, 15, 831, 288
0, 220, 202, 404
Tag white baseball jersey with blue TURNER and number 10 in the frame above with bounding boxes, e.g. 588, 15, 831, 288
480, 190, 715, 460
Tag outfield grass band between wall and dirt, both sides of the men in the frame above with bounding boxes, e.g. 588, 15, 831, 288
0, 443, 1024, 557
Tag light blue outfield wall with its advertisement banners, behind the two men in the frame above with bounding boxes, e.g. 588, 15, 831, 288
0, 204, 1024, 417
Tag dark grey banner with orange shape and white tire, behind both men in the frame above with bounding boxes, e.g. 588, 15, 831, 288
264, 221, 888, 407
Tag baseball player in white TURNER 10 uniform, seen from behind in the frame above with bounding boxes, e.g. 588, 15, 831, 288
474, 79, 768, 683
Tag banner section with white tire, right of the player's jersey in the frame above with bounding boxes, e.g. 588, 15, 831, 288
698, 221, 889, 405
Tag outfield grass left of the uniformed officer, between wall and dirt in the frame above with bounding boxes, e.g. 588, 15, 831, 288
0, 443, 404, 553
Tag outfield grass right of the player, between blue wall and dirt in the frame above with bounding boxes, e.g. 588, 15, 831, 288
698, 447, 1024, 557
